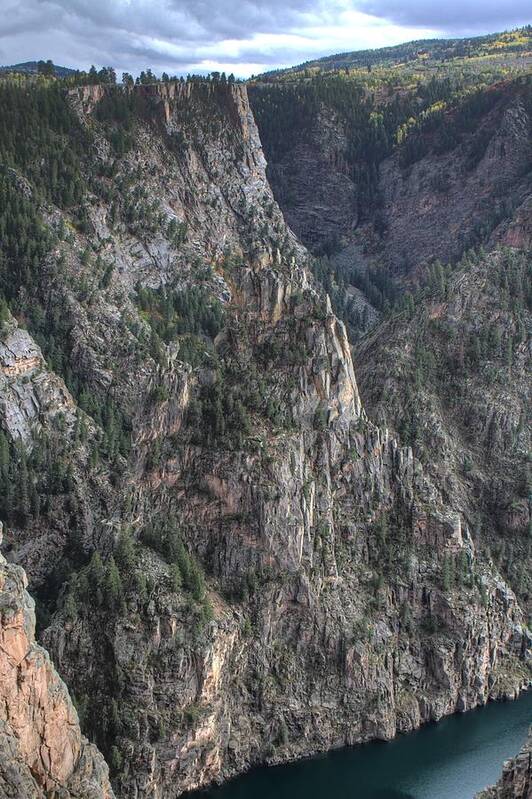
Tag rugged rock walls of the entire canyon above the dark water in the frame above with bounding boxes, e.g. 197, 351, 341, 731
0, 34, 532, 799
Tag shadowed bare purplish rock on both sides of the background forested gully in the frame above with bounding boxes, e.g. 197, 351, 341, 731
252, 79, 532, 278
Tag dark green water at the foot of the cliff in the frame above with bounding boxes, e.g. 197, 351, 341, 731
194, 691, 532, 799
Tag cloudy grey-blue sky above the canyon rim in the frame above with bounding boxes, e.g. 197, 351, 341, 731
0, 0, 532, 77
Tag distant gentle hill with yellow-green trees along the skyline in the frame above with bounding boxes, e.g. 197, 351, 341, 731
266, 25, 532, 76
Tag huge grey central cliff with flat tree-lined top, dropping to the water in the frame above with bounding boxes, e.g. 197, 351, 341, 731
0, 72, 530, 799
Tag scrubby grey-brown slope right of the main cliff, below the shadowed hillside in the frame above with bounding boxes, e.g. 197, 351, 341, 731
355, 250, 532, 620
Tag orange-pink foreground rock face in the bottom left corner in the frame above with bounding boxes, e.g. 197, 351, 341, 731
0, 528, 114, 799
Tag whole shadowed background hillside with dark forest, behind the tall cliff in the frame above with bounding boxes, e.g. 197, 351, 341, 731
250, 56, 532, 340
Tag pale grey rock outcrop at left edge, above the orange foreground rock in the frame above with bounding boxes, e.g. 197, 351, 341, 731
0, 317, 114, 588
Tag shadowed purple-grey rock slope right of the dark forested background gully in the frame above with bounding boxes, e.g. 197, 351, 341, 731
374, 86, 532, 274
